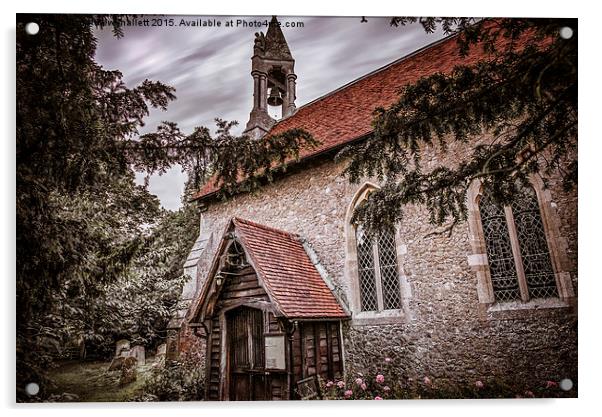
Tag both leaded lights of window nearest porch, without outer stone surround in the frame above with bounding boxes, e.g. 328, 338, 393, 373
355, 226, 401, 311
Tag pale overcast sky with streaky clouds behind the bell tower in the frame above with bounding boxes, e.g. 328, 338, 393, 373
96, 16, 441, 210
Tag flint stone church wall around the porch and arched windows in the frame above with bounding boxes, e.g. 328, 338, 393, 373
180, 138, 577, 387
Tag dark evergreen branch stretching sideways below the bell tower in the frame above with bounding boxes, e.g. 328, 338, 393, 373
133, 118, 319, 197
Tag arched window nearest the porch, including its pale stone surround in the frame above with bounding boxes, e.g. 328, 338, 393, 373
345, 182, 409, 324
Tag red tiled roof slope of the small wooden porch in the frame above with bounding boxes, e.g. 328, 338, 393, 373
232, 218, 348, 318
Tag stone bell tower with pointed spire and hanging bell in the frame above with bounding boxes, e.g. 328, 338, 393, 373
244, 16, 297, 139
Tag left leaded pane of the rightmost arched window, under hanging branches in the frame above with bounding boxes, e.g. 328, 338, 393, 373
479, 195, 520, 302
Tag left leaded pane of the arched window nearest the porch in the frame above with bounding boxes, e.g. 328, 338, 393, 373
355, 227, 378, 311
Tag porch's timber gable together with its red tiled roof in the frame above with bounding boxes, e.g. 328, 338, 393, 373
192, 218, 348, 321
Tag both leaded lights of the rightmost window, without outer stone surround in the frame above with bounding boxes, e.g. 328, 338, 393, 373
479, 187, 558, 302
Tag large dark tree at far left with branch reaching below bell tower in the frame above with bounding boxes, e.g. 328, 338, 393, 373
16, 14, 315, 393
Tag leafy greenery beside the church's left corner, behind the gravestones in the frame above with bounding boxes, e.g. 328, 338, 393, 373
94, 200, 198, 349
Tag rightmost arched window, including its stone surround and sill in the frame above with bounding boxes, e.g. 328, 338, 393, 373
468, 176, 574, 309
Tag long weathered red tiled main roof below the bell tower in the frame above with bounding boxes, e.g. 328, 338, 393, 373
193, 30, 496, 199
